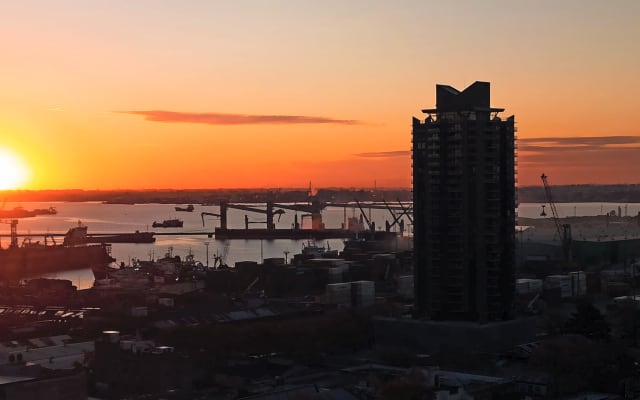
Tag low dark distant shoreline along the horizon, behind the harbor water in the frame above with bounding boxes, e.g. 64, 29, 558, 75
0, 184, 640, 204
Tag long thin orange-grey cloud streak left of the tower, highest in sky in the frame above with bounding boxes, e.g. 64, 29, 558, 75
116, 110, 361, 125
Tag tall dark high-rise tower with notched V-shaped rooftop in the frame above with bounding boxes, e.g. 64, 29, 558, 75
412, 82, 516, 322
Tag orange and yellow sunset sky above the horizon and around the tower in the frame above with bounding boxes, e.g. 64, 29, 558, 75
0, 0, 640, 190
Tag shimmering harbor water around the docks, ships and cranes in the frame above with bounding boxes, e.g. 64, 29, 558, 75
0, 202, 640, 289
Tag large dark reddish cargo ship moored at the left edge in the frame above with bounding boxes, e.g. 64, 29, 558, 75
0, 220, 115, 282
